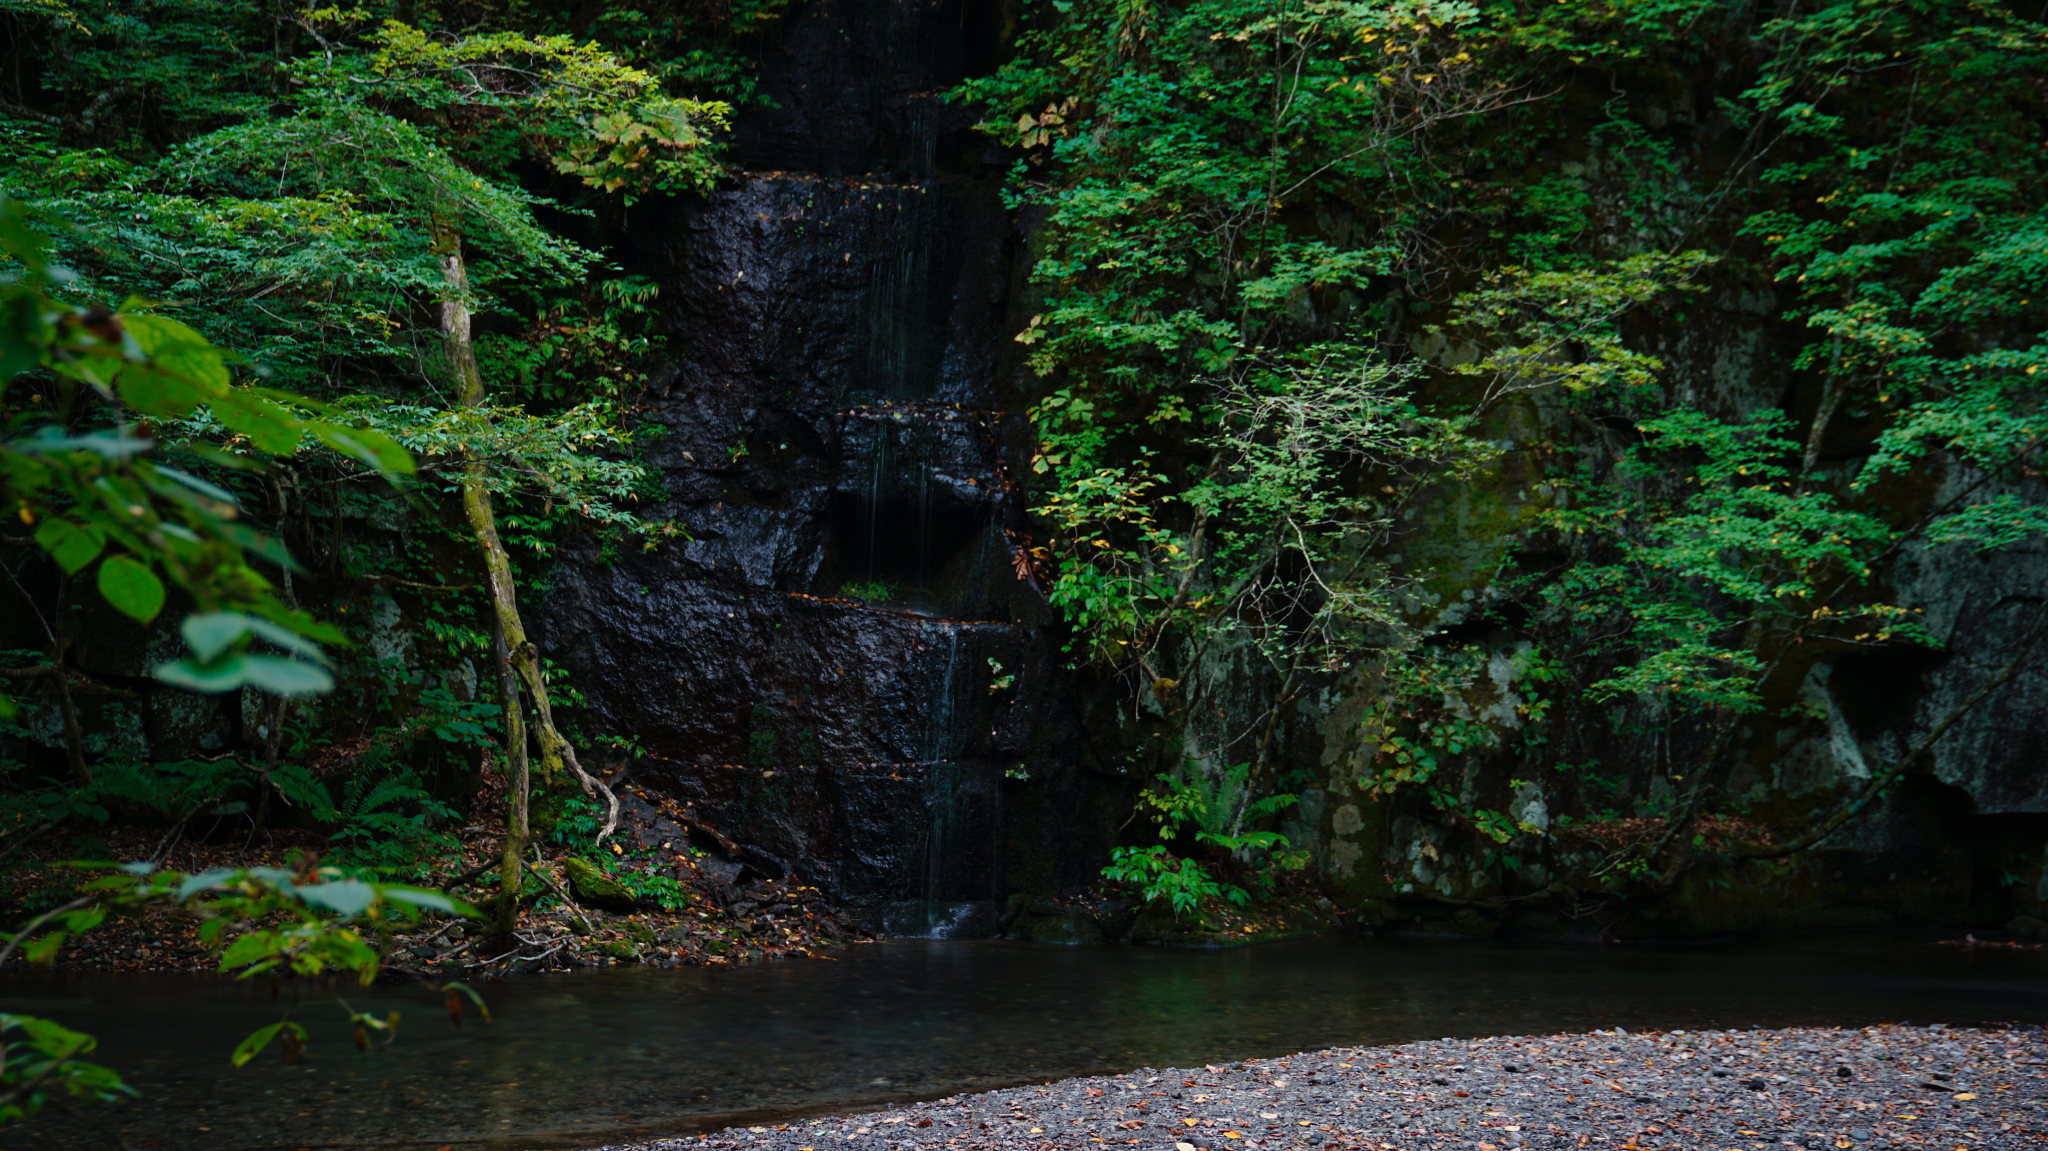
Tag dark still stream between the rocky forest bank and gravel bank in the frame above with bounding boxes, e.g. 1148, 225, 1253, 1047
0, 936, 2048, 1151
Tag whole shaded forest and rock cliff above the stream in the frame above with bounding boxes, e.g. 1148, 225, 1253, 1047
0, 0, 2048, 1064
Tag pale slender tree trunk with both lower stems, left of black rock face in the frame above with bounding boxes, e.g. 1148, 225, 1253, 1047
432, 210, 618, 930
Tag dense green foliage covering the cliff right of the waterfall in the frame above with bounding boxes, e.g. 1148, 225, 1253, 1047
978, 0, 2048, 875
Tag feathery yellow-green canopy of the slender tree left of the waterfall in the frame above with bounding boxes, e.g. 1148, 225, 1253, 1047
8, 6, 725, 618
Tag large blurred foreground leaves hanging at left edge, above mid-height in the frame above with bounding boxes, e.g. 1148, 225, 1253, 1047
0, 199, 412, 694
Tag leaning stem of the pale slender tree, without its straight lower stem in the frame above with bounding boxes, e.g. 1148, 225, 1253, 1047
432, 217, 618, 840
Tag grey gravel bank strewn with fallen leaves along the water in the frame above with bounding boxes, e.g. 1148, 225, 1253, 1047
604, 1024, 2048, 1151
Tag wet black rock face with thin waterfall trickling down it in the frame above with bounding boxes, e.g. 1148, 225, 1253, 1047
539, 0, 1133, 921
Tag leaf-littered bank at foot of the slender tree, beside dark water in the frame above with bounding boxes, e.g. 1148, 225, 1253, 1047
0, 772, 868, 979
